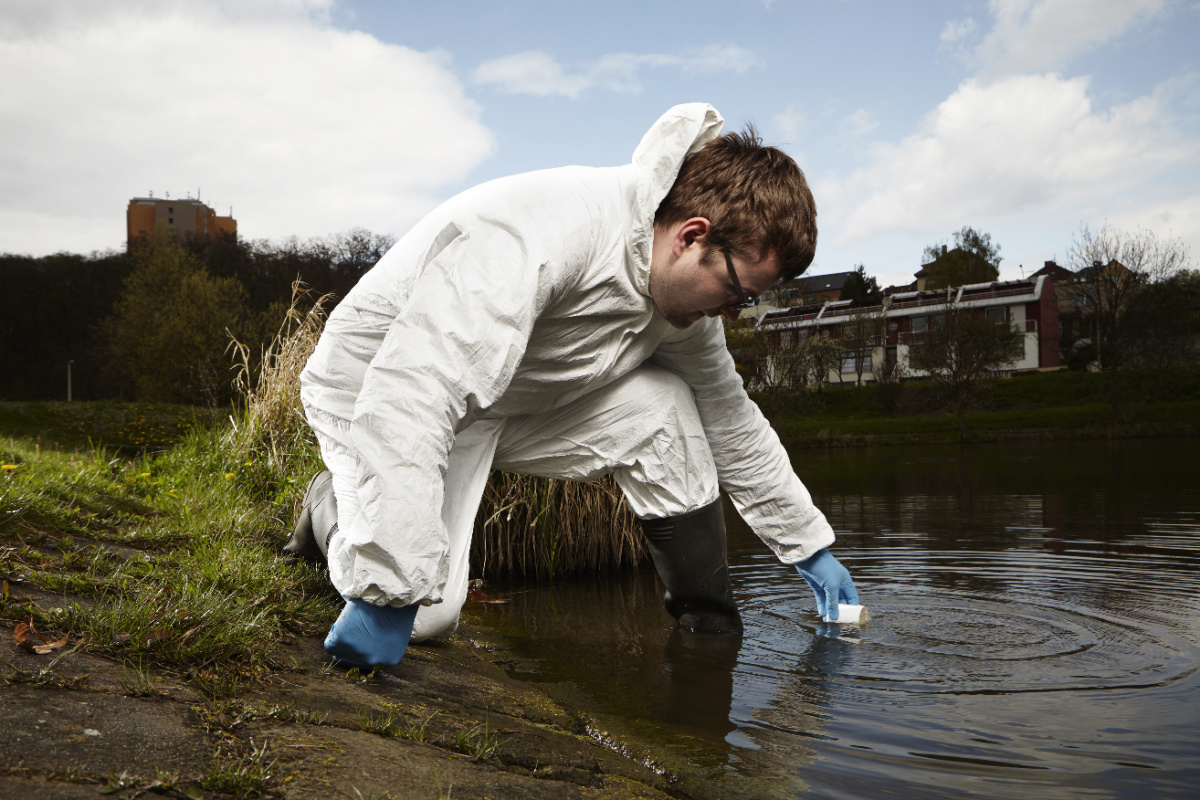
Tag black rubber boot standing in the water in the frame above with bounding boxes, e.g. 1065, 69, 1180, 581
642, 498, 742, 633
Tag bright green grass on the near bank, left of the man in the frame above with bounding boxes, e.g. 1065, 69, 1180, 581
0, 404, 341, 676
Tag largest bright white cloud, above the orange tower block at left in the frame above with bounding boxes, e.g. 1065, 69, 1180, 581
0, 0, 492, 253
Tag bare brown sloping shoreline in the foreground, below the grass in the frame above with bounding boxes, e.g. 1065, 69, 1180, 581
0, 575, 703, 800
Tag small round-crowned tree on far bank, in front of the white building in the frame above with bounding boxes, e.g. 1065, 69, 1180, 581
908, 303, 1025, 439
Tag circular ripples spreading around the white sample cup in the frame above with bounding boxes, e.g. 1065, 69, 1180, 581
742, 587, 1200, 694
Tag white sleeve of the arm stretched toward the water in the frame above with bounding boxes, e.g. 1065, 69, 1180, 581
653, 318, 834, 564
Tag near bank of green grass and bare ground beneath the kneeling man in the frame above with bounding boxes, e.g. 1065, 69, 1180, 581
0, 404, 688, 800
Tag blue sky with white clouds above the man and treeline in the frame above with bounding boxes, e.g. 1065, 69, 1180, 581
0, 0, 1200, 285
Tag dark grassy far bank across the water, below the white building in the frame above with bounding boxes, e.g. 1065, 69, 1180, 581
756, 367, 1200, 447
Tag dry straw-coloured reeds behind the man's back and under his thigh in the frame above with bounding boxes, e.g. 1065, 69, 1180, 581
229, 281, 649, 579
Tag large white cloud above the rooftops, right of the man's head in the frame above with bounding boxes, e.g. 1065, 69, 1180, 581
820, 76, 1200, 243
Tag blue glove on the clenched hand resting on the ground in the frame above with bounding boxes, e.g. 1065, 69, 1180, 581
325, 597, 416, 669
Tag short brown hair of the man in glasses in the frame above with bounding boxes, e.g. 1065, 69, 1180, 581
654, 125, 817, 281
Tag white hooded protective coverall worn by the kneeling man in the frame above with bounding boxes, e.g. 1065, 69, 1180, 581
301, 103, 834, 640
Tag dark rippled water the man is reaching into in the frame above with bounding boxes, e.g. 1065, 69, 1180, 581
472, 439, 1200, 800
